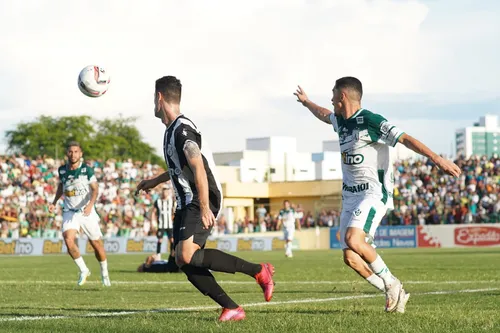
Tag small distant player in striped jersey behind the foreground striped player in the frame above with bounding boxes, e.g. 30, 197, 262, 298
151, 182, 178, 271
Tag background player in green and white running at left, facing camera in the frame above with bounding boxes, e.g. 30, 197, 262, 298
49, 141, 111, 287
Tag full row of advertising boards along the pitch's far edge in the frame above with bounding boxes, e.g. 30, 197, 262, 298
0, 224, 500, 255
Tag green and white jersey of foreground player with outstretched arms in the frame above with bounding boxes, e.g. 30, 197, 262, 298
330, 109, 404, 208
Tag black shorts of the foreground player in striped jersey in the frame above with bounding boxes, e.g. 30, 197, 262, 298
174, 204, 217, 248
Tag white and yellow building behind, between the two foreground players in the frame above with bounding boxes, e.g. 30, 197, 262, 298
213, 136, 408, 223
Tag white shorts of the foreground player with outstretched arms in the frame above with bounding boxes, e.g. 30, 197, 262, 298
340, 198, 387, 249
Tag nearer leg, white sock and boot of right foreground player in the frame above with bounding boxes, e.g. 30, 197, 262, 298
345, 227, 407, 312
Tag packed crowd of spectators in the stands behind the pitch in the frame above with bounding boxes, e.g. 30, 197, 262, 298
0, 155, 500, 238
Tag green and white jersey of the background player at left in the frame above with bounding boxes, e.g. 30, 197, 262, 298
58, 162, 97, 211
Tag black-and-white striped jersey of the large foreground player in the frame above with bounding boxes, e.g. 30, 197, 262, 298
163, 114, 222, 216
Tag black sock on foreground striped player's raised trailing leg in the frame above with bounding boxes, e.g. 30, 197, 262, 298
190, 249, 262, 277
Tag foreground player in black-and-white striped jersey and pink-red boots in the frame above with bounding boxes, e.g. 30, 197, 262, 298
136, 76, 274, 321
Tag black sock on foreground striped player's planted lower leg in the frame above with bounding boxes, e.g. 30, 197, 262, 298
181, 265, 238, 309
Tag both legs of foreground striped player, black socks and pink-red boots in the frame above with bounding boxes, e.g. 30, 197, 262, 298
175, 236, 274, 321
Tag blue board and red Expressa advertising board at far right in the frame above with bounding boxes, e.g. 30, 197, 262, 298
330, 224, 500, 249
